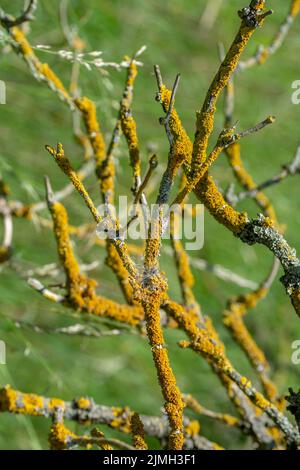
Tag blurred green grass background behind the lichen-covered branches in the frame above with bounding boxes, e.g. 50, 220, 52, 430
0, 0, 300, 449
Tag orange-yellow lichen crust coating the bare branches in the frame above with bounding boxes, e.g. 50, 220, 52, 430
0, 0, 300, 450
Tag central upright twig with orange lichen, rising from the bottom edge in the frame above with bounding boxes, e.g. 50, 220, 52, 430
137, 72, 189, 450
